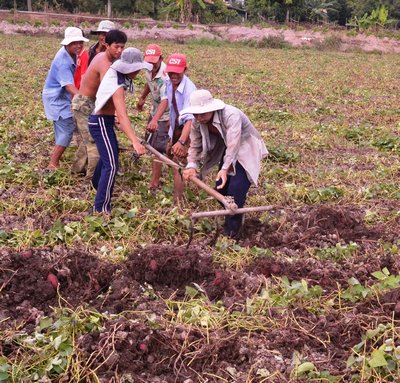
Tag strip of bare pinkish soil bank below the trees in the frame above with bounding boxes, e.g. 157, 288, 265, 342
0, 18, 400, 53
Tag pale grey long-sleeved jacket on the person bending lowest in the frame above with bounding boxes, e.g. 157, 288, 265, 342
186, 105, 268, 185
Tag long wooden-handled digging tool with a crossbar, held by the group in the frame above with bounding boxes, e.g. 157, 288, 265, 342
142, 141, 273, 247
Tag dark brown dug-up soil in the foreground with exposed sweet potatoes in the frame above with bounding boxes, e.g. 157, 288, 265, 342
0, 205, 400, 382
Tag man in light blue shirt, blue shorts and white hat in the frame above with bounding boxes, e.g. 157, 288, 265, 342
42, 27, 89, 170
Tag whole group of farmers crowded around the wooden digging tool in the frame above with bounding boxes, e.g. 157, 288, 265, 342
42, 20, 267, 237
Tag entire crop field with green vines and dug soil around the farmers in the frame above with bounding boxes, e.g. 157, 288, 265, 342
0, 29, 400, 383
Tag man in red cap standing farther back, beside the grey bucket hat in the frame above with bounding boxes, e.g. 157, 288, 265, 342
136, 44, 169, 191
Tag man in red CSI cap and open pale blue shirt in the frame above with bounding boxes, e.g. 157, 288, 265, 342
165, 53, 196, 204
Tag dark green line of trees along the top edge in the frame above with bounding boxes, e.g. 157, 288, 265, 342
0, 0, 400, 29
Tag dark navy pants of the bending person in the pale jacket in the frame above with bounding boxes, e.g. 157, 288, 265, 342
216, 162, 250, 237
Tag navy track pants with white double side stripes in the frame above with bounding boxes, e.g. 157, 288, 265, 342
89, 114, 118, 213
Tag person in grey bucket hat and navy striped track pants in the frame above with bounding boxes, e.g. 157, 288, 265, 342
89, 48, 152, 214
